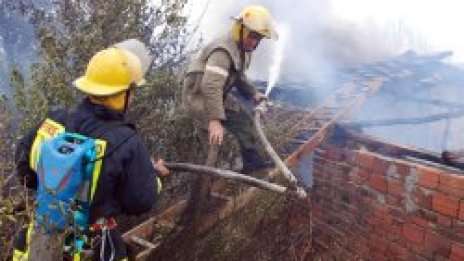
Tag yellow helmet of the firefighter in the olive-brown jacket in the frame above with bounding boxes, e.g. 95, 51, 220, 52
232, 5, 278, 41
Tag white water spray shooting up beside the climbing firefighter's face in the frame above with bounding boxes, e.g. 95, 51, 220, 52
265, 25, 290, 96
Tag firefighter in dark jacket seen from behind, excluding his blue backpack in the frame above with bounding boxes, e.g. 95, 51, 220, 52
13, 39, 169, 260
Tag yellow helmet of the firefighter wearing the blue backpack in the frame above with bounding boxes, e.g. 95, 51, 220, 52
74, 47, 145, 96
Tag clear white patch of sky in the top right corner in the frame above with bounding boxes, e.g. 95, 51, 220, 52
332, 0, 464, 58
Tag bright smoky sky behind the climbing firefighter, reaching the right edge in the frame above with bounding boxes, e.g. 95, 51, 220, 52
190, 0, 464, 81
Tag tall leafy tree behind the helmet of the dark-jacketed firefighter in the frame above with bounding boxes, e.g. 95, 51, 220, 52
3, 0, 199, 154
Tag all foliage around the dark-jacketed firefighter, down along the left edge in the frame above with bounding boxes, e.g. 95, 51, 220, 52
0, 0, 192, 256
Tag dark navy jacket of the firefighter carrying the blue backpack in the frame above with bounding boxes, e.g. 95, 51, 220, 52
16, 99, 158, 224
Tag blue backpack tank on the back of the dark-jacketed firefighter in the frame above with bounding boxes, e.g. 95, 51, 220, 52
35, 132, 98, 233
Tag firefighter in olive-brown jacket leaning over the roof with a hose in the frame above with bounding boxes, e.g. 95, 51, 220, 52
182, 5, 277, 173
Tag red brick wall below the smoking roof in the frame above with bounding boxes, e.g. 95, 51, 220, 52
312, 137, 464, 260
